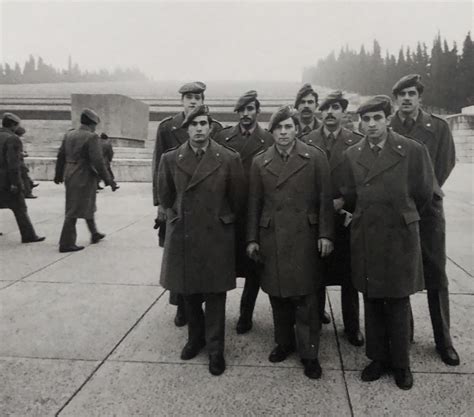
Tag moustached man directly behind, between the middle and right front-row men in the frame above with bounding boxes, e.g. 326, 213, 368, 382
301, 91, 364, 346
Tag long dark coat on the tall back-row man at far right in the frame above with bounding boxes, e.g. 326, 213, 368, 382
391, 111, 456, 289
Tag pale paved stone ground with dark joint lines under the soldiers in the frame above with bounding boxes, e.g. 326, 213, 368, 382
0, 165, 474, 417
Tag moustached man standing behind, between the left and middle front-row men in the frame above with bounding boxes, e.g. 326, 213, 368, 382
215, 90, 273, 334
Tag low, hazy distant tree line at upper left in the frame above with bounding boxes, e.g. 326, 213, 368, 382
0, 55, 148, 84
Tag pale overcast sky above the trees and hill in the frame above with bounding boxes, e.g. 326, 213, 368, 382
0, 0, 473, 81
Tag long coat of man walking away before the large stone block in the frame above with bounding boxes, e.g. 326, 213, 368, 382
55, 125, 111, 219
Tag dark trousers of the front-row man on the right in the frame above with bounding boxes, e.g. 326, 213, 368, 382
364, 295, 411, 369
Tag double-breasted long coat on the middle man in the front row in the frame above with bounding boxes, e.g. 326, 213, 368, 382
247, 140, 334, 297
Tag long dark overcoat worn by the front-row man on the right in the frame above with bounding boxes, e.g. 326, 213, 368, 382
343, 132, 434, 298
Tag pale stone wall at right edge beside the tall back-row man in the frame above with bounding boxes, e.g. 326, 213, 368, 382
446, 114, 474, 164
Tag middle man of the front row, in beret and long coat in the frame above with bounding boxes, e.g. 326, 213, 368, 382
247, 106, 334, 379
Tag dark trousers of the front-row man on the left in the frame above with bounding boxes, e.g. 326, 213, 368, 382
183, 292, 227, 355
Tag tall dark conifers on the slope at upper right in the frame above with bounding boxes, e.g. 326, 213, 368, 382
303, 32, 474, 113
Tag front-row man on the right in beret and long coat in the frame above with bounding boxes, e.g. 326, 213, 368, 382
341, 96, 434, 389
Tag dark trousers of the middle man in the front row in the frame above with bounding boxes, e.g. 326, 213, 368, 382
269, 293, 321, 359
